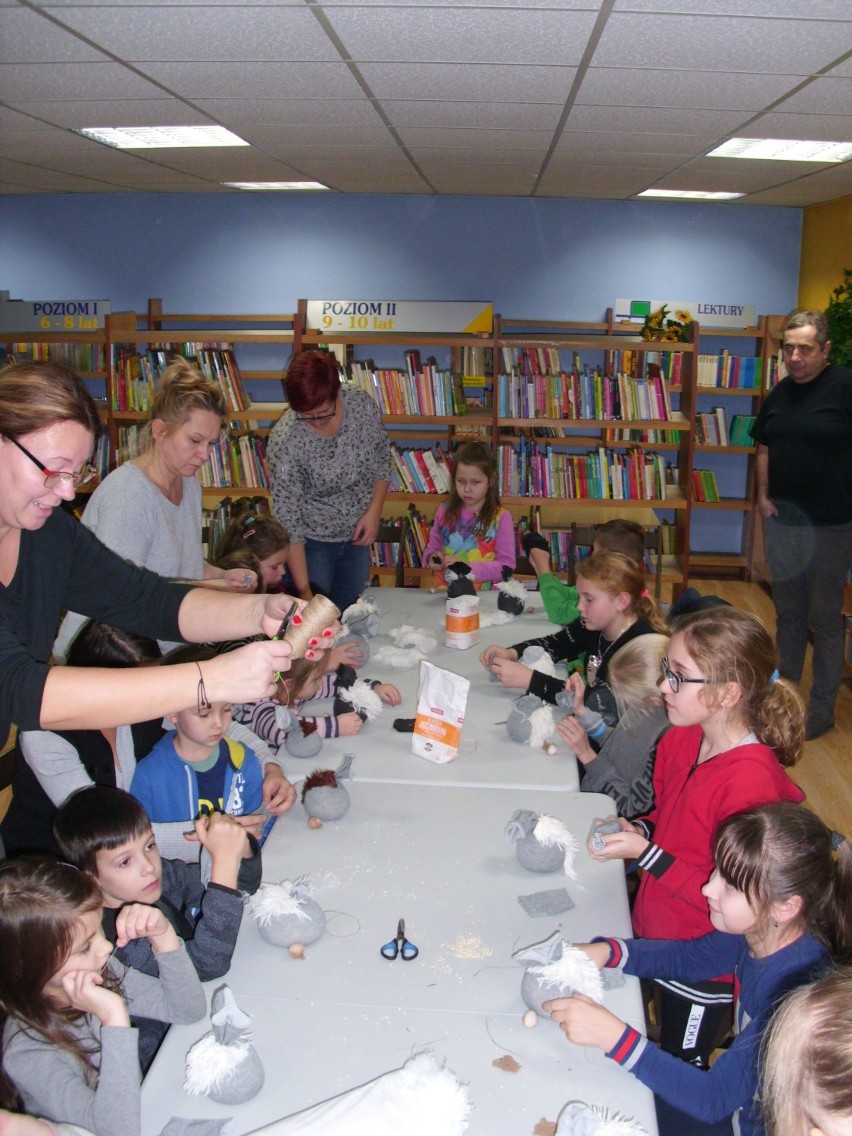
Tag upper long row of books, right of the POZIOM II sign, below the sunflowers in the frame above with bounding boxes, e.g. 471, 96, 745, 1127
498, 368, 671, 421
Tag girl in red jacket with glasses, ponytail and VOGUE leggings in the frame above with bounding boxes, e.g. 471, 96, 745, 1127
590, 608, 804, 1067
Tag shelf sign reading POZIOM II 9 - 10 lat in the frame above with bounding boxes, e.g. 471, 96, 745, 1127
307, 300, 494, 335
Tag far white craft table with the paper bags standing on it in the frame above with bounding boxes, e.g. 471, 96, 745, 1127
290, 588, 579, 791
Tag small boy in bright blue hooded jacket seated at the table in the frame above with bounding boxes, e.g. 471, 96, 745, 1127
131, 645, 264, 835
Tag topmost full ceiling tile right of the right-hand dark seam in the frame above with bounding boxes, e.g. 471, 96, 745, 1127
592, 10, 850, 75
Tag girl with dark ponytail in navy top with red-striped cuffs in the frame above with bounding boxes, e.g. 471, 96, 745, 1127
544, 802, 852, 1136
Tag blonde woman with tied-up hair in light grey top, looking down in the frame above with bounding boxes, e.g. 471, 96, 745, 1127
53, 358, 257, 662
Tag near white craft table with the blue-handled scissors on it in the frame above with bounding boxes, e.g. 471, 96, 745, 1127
142, 782, 657, 1136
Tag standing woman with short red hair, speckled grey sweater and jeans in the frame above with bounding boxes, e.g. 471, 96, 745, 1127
267, 351, 391, 611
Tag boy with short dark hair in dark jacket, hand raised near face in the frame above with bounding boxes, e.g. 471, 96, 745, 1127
53, 785, 261, 1071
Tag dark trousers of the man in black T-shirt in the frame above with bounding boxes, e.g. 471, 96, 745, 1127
763, 517, 852, 719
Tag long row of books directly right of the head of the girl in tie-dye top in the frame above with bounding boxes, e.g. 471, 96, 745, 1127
498, 438, 674, 501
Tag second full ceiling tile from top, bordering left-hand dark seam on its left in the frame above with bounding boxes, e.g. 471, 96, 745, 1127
141, 62, 364, 100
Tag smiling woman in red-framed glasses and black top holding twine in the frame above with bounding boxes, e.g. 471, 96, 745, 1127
0, 362, 329, 772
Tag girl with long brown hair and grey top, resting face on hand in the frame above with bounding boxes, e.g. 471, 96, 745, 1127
0, 859, 207, 1136
